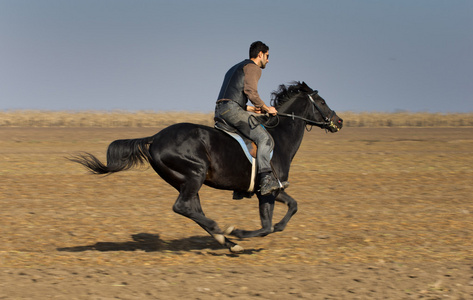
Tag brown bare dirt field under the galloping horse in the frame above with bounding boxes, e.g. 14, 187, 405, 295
0, 127, 473, 299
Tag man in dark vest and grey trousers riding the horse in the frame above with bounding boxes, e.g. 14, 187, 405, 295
215, 41, 280, 195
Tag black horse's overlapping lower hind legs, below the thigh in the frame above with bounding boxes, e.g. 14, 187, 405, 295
172, 189, 243, 252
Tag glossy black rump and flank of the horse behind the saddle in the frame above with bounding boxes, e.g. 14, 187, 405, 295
149, 123, 251, 189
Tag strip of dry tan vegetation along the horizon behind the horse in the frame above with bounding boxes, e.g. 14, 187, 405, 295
0, 110, 473, 127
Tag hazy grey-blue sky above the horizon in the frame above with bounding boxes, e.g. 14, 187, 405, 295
0, 0, 473, 112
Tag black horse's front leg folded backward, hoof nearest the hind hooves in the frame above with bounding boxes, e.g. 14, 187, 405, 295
225, 194, 275, 238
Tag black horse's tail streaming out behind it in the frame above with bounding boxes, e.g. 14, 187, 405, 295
68, 137, 153, 174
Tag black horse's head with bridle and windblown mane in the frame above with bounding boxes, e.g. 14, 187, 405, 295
272, 82, 343, 132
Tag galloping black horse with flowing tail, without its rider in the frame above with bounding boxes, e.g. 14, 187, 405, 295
70, 82, 343, 252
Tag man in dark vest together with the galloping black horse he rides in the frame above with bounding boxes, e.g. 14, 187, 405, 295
70, 42, 343, 253
